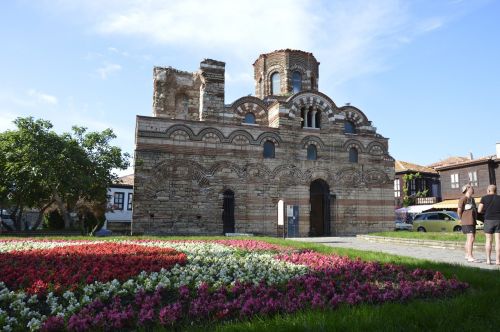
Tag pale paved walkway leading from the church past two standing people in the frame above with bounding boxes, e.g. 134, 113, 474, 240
290, 237, 500, 270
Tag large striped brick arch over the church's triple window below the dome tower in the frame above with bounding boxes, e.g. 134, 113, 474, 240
287, 90, 338, 121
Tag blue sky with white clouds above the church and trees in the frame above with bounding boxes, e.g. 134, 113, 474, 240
0, 0, 500, 174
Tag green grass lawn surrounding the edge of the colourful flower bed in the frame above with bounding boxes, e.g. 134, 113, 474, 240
3, 232, 500, 332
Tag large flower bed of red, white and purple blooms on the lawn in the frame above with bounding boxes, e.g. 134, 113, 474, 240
0, 240, 467, 331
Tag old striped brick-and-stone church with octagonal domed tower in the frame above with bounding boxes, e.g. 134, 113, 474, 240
132, 49, 394, 237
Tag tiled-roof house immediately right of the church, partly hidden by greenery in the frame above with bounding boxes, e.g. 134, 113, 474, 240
394, 160, 441, 208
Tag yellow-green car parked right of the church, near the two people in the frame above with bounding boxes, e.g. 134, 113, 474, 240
413, 211, 462, 232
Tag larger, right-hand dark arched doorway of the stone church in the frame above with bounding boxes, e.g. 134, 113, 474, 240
309, 179, 330, 236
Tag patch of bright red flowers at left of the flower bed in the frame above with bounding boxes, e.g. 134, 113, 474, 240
0, 242, 187, 294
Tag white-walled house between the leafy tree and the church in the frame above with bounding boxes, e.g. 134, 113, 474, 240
104, 174, 134, 234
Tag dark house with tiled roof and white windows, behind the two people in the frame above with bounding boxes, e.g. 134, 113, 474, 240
429, 143, 500, 200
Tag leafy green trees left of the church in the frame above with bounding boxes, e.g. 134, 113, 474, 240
0, 117, 129, 229
